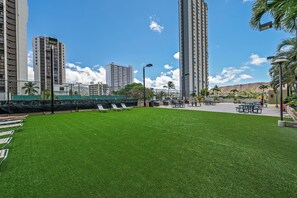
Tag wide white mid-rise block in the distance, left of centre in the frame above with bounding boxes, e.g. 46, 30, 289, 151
106, 63, 134, 93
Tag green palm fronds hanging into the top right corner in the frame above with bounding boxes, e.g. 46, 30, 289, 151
250, 0, 297, 32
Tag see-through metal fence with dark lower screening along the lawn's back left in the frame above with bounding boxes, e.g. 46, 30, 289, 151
0, 80, 137, 114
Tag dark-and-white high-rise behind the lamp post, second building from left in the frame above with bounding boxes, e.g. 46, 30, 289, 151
32, 36, 66, 91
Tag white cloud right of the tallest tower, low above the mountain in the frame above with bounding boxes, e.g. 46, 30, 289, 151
208, 66, 253, 87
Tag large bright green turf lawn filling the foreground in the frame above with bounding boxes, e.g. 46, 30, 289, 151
0, 108, 297, 198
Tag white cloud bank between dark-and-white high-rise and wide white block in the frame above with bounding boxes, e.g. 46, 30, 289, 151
66, 63, 106, 84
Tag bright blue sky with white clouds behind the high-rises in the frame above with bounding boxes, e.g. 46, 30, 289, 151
28, 0, 290, 88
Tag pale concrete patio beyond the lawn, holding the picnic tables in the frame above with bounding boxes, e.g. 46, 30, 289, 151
159, 103, 290, 117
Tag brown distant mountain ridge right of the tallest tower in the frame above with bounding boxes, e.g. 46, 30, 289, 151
219, 82, 272, 93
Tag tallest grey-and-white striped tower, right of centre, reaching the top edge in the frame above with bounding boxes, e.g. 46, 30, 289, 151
179, 0, 208, 98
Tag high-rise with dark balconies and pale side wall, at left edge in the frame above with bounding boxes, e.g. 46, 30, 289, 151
0, 0, 28, 99
